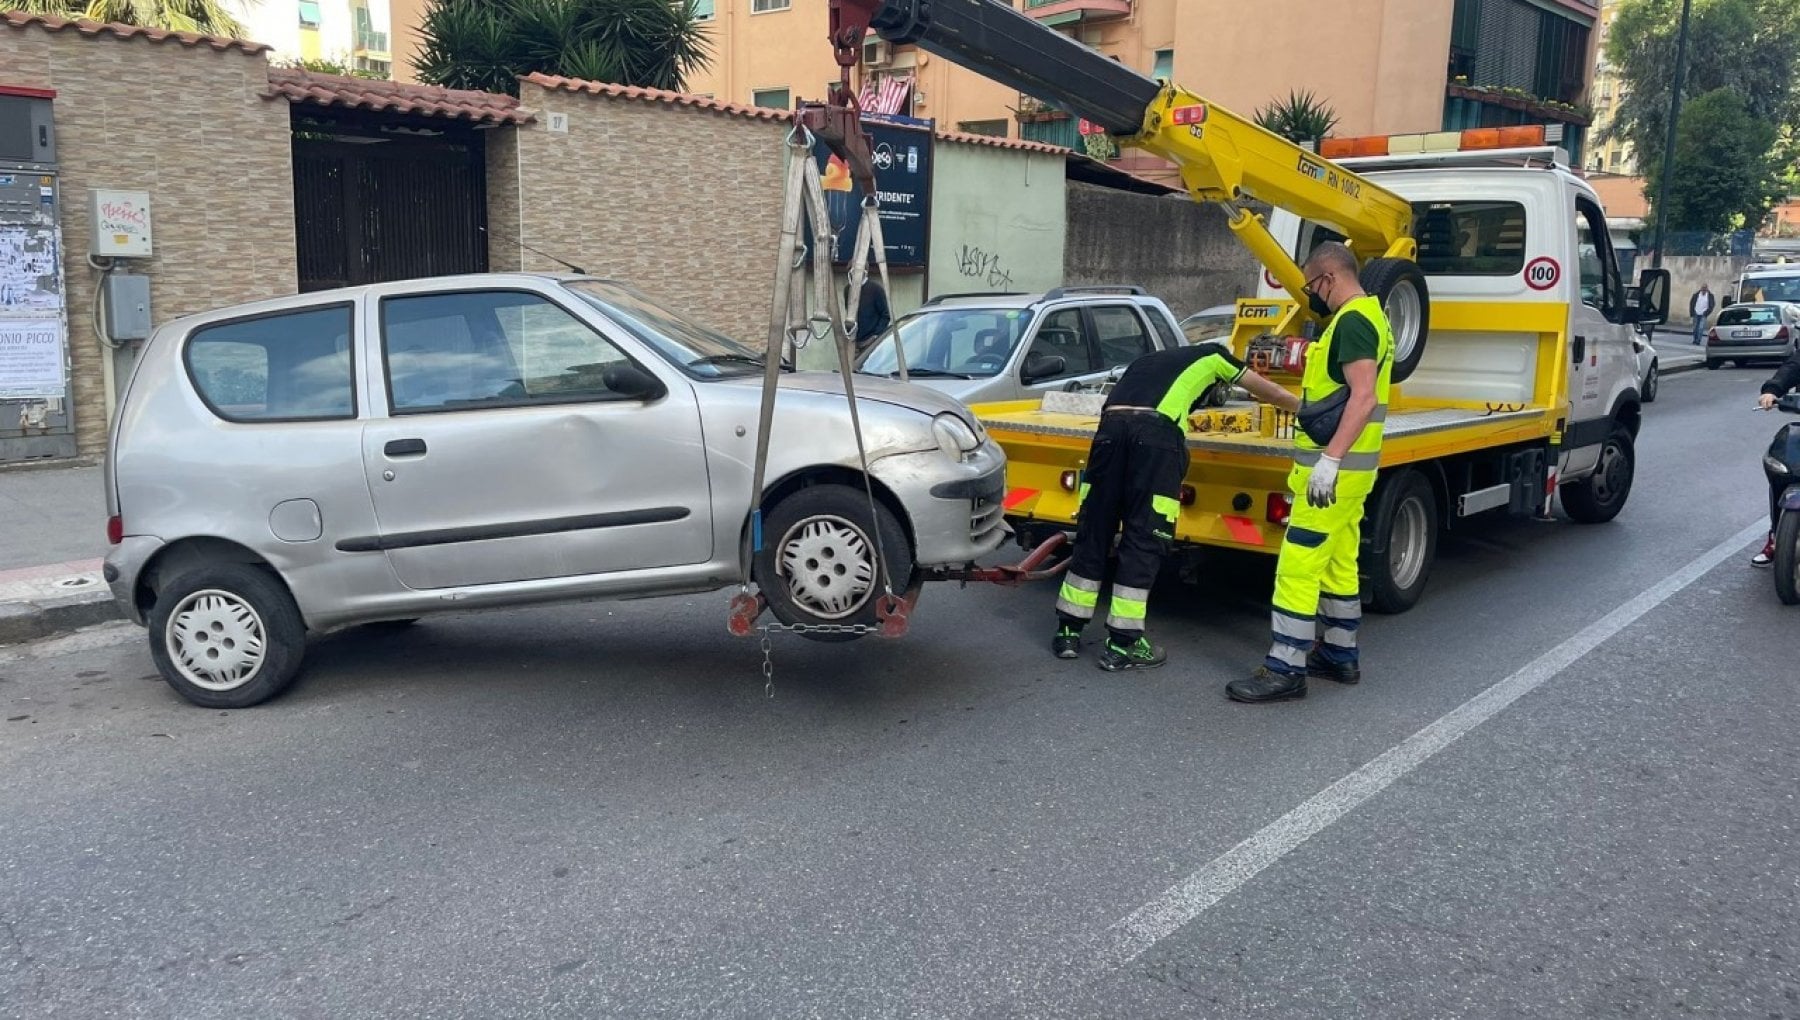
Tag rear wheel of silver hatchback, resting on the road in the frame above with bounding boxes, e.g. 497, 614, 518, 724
148, 563, 306, 709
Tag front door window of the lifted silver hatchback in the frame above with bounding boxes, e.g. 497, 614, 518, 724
382, 291, 628, 414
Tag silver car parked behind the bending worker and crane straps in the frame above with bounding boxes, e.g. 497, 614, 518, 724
857, 286, 1181, 405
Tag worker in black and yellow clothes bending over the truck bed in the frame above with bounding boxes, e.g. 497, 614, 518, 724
1051, 344, 1300, 673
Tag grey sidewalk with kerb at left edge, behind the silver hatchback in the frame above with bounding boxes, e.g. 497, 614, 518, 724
0, 468, 119, 646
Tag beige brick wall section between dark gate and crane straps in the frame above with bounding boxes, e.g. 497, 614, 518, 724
504, 81, 787, 347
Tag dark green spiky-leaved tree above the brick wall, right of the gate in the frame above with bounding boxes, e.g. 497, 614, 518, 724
414, 0, 709, 95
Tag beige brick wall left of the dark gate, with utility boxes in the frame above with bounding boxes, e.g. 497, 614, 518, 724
0, 25, 295, 455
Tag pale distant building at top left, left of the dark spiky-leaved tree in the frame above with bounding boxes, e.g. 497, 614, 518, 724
229, 0, 394, 77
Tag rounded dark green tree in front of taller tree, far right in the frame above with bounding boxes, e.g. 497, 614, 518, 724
1651, 88, 1782, 234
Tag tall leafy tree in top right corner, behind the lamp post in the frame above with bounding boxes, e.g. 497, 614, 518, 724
1606, 0, 1800, 230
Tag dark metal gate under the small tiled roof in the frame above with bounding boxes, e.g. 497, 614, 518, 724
293, 124, 488, 291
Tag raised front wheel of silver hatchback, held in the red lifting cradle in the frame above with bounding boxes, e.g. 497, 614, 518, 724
756, 486, 913, 642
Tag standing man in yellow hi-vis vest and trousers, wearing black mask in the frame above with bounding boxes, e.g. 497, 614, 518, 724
1226, 241, 1393, 702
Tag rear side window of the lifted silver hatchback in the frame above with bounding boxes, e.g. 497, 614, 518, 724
184, 304, 356, 421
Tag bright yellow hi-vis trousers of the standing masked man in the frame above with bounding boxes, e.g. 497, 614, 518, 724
1264, 468, 1375, 676
